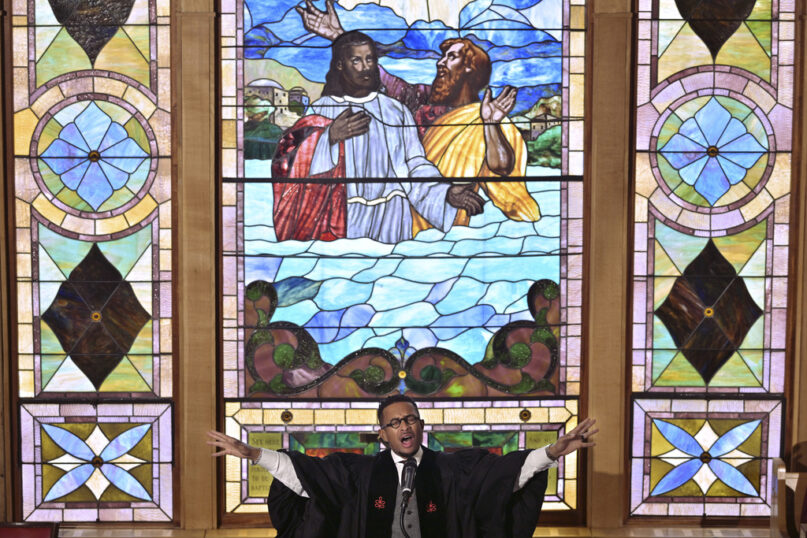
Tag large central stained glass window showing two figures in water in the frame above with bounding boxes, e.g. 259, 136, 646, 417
220, 0, 586, 514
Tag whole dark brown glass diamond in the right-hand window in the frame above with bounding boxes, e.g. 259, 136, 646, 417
655, 239, 762, 383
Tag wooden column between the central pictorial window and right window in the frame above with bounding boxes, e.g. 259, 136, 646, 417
584, 0, 633, 529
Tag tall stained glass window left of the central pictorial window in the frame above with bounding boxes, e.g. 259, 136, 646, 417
12, 0, 174, 522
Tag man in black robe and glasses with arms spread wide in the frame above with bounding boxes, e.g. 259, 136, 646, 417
208, 395, 597, 538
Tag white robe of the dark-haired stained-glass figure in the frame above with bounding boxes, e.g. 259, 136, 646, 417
309, 92, 457, 243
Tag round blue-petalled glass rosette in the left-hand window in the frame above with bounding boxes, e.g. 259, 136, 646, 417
32, 99, 155, 215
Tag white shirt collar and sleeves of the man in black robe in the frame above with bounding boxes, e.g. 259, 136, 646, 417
254, 445, 558, 497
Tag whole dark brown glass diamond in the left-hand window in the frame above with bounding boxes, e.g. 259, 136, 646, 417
42, 244, 151, 389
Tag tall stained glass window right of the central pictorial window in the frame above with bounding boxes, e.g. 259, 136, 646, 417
630, 0, 795, 516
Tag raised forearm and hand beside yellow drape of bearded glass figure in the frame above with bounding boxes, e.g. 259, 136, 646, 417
480, 86, 516, 176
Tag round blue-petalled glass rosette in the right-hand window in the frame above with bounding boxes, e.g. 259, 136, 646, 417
655, 96, 770, 209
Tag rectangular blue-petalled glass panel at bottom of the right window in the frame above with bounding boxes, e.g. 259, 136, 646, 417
631, 399, 782, 516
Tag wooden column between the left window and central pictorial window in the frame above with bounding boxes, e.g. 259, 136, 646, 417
173, 0, 219, 529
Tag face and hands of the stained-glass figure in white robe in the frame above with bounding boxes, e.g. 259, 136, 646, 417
328, 44, 487, 216
